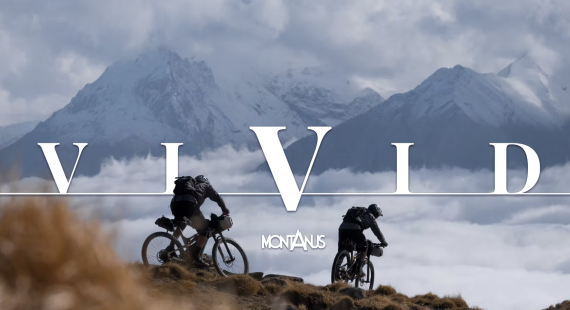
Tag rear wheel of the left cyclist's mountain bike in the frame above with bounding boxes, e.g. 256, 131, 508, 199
141, 232, 184, 267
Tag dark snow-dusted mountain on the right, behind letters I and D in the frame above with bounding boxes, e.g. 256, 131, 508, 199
280, 56, 570, 174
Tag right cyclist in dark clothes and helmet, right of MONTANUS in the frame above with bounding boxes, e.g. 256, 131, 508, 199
338, 204, 388, 277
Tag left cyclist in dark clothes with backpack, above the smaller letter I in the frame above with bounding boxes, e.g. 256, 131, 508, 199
170, 175, 230, 267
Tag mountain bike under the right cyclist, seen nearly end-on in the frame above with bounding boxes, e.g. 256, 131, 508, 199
331, 240, 384, 290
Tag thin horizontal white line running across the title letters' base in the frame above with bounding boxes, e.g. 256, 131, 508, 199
0, 193, 570, 196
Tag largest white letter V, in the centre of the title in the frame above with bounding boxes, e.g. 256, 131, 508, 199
249, 127, 331, 211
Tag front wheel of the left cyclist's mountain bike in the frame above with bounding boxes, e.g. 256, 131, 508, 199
212, 238, 249, 277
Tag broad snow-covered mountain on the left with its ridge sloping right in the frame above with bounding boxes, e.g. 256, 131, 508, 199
0, 49, 383, 176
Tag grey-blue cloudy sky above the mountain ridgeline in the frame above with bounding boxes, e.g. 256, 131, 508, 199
0, 0, 570, 126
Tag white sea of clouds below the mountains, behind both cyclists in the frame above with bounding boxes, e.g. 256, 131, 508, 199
6, 147, 570, 309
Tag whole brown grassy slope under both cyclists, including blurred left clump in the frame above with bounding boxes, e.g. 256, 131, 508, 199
0, 198, 486, 310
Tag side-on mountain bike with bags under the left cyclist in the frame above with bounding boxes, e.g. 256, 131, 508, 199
142, 213, 249, 277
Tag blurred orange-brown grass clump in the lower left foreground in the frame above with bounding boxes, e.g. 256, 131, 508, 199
0, 198, 197, 310
